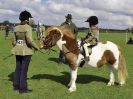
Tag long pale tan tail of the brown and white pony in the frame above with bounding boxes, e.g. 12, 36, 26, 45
118, 49, 128, 85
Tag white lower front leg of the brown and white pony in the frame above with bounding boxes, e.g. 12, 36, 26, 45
68, 67, 78, 92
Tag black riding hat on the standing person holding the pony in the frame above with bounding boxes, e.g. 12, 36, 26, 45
19, 10, 33, 21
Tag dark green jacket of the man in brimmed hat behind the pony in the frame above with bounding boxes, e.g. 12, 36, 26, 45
61, 21, 78, 38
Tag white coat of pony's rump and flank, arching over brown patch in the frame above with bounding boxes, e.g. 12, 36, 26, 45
88, 41, 119, 67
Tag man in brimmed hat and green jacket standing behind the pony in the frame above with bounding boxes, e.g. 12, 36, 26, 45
59, 14, 78, 63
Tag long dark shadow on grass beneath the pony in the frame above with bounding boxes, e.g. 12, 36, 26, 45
30, 72, 109, 86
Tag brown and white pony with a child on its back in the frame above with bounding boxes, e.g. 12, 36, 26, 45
40, 27, 127, 92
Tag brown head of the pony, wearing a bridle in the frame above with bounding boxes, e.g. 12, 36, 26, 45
40, 28, 61, 49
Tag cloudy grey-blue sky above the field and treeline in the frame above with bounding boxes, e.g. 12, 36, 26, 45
0, 0, 133, 29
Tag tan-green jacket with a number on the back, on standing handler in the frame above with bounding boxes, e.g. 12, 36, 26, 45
11, 24, 39, 56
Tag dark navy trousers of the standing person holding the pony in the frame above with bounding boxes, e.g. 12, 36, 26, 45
13, 55, 32, 90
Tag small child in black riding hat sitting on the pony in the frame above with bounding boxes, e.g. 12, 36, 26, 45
83, 16, 99, 61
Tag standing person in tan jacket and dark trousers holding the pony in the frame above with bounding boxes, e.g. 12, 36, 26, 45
11, 10, 39, 93
